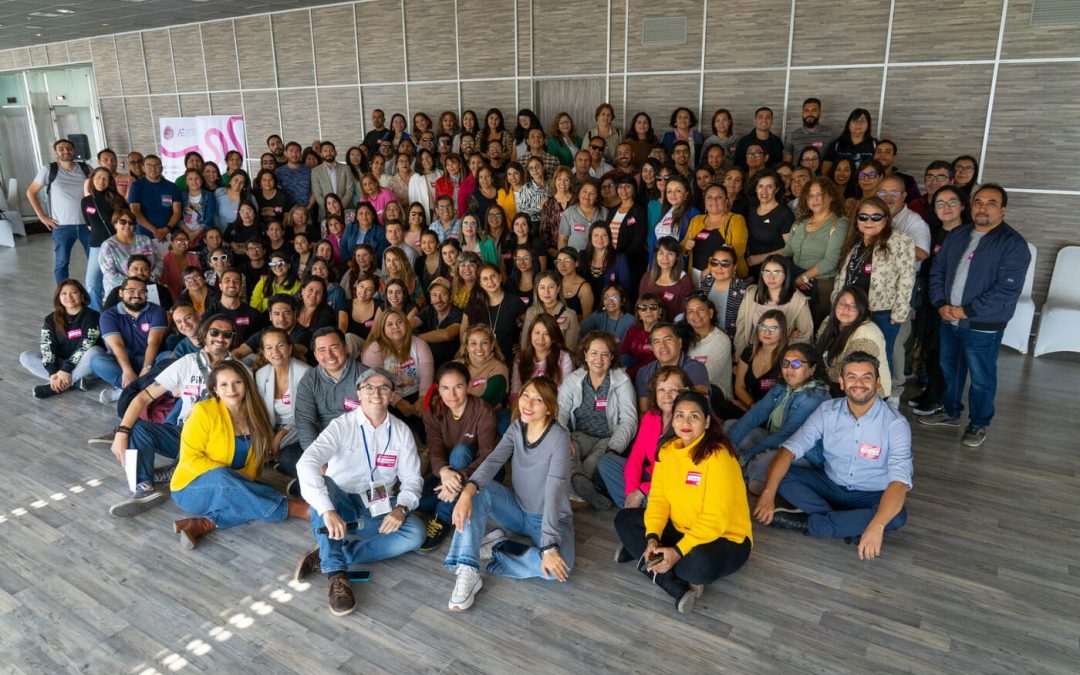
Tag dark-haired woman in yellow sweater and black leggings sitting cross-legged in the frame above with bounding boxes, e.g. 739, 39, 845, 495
615, 391, 753, 613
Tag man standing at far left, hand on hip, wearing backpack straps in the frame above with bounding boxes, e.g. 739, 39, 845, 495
26, 138, 90, 287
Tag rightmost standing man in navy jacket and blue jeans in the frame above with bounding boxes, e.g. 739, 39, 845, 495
919, 183, 1031, 447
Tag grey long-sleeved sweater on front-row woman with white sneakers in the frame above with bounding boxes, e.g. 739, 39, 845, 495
471, 420, 572, 549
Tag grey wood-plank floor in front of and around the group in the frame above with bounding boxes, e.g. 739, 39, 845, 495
0, 235, 1080, 674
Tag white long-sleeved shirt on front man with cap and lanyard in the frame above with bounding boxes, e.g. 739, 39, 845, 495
296, 408, 423, 515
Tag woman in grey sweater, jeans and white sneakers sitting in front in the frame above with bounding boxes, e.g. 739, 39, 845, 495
443, 377, 574, 611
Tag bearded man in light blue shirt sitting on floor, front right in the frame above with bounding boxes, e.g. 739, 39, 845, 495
754, 352, 913, 559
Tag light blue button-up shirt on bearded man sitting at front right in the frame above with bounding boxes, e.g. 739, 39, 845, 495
784, 399, 914, 491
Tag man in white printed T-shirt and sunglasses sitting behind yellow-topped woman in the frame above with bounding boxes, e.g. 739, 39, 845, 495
109, 314, 235, 517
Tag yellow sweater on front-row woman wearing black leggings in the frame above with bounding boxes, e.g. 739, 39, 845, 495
645, 436, 754, 556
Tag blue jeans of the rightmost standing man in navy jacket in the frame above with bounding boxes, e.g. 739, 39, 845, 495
940, 321, 1003, 429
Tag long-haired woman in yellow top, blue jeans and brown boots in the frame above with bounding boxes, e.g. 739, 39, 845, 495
170, 361, 309, 549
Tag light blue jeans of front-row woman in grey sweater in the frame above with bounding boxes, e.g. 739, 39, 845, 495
443, 482, 573, 579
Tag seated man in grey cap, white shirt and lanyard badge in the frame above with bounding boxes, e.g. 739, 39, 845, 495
296, 368, 424, 617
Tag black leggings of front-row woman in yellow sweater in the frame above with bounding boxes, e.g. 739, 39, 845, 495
615, 509, 751, 584
